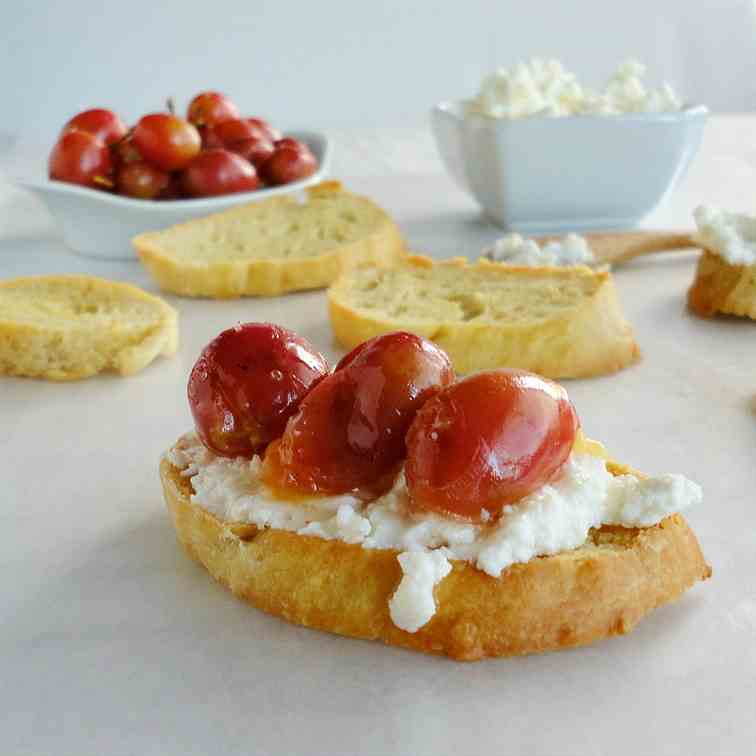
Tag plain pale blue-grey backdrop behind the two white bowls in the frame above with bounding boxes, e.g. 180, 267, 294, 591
0, 0, 756, 143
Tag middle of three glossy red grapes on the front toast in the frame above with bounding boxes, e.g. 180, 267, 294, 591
265, 331, 454, 495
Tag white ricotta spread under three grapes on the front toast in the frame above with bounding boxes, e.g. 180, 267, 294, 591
166, 434, 702, 633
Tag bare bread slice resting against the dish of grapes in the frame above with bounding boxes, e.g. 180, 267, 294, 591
133, 181, 405, 299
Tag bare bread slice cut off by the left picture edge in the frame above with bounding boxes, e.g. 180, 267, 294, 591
0, 276, 178, 381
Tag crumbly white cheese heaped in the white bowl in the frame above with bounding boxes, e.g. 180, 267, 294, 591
468, 58, 682, 118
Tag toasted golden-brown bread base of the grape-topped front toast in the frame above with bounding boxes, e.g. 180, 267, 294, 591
160, 442, 711, 660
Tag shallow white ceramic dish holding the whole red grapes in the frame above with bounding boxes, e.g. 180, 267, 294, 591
19, 131, 331, 260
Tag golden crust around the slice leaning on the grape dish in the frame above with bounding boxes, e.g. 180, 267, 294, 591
133, 181, 406, 299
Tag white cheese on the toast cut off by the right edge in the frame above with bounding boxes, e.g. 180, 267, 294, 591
693, 205, 756, 265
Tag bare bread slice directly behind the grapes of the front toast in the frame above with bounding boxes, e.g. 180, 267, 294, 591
328, 256, 640, 378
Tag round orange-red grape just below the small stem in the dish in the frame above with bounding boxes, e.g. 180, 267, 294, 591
133, 113, 202, 172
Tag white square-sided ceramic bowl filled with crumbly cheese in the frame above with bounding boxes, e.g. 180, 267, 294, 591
431, 102, 708, 233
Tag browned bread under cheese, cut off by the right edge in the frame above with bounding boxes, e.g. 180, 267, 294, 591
688, 249, 756, 320
